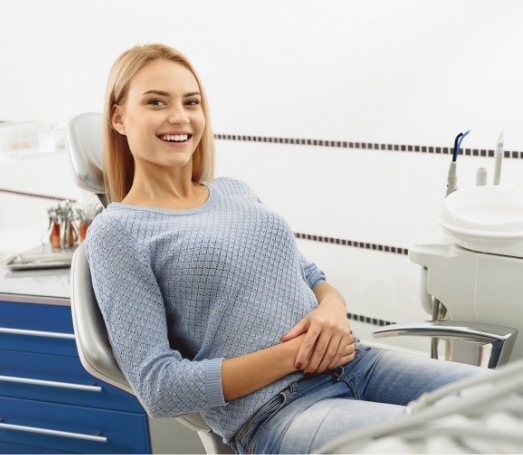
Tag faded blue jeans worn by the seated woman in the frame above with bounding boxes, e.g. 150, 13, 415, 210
232, 346, 486, 453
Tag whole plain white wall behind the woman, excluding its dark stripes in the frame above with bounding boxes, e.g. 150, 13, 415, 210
0, 0, 523, 352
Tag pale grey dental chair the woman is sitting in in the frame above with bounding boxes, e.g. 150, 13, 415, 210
66, 113, 234, 453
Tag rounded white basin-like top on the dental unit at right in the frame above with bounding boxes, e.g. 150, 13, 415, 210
439, 185, 523, 258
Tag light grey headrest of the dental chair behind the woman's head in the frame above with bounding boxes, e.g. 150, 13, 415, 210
65, 113, 106, 194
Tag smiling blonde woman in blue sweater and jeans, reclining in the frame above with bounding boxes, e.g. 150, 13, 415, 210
86, 45, 484, 453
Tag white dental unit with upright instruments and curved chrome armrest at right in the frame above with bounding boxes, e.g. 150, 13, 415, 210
374, 131, 523, 368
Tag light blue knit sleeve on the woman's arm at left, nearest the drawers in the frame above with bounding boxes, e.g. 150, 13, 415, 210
86, 216, 226, 417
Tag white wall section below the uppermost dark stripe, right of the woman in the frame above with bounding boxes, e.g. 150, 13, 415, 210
212, 137, 523, 352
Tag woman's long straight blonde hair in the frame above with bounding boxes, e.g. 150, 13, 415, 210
104, 44, 214, 202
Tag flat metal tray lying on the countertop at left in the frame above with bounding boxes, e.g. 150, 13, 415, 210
5, 245, 76, 270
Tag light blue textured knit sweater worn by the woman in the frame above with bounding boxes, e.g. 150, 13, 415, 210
86, 178, 325, 440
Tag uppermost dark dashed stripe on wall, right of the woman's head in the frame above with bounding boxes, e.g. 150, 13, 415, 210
214, 134, 523, 159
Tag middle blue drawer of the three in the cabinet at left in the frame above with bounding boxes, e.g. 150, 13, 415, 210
0, 350, 144, 413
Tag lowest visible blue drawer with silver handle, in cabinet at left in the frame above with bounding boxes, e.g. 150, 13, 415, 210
0, 397, 151, 453
